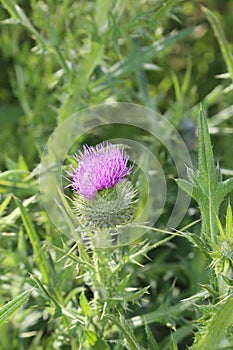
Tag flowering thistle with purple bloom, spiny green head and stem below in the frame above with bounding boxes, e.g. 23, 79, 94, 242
61, 142, 148, 349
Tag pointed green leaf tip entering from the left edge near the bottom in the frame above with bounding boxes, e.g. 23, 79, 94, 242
0, 290, 31, 325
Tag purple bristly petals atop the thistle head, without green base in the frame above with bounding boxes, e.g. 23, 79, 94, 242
67, 142, 133, 200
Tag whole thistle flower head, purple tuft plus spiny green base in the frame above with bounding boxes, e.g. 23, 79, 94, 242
67, 142, 136, 228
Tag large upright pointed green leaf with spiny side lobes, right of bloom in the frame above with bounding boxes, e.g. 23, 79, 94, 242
177, 109, 233, 242
